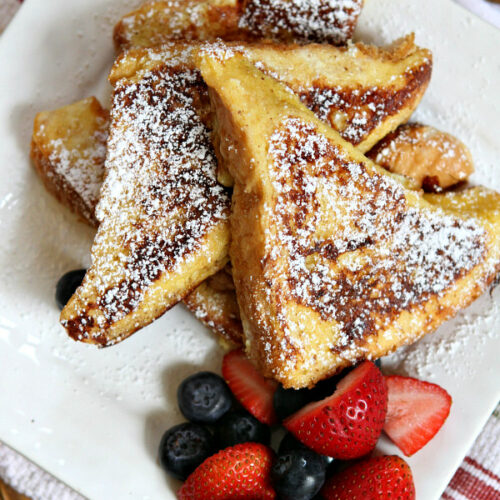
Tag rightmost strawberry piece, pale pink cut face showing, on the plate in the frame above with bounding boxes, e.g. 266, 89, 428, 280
384, 375, 451, 457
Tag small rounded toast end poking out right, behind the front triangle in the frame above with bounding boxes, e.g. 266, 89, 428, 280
367, 123, 474, 191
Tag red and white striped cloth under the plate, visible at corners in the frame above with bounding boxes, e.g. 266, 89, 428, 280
0, 0, 500, 500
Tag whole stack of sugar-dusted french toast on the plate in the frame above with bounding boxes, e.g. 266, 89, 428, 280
31, 0, 500, 388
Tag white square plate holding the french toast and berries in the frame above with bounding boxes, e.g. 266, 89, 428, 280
0, 0, 500, 500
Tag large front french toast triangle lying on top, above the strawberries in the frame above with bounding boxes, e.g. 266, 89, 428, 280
198, 48, 500, 388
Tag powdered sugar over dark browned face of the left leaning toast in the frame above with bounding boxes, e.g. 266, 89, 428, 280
64, 48, 229, 343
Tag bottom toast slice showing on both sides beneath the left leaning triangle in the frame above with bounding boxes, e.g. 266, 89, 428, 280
32, 97, 243, 348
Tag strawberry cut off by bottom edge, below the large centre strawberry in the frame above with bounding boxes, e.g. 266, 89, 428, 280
320, 455, 415, 500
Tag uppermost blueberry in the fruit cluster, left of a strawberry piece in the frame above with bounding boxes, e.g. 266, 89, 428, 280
177, 372, 233, 424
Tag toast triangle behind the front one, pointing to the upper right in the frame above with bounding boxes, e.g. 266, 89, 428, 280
215, 34, 432, 186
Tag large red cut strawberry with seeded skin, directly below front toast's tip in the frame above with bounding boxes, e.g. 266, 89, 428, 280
283, 361, 387, 460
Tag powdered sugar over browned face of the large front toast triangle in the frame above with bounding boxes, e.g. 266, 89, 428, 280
263, 119, 494, 372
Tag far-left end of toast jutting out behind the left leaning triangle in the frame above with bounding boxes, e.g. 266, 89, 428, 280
31, 97, 109, 226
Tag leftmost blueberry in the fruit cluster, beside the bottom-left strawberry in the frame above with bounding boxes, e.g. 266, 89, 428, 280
159, 422, 214, 480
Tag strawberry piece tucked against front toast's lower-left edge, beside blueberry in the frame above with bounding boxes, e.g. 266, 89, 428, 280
222, 350, 278, 425
